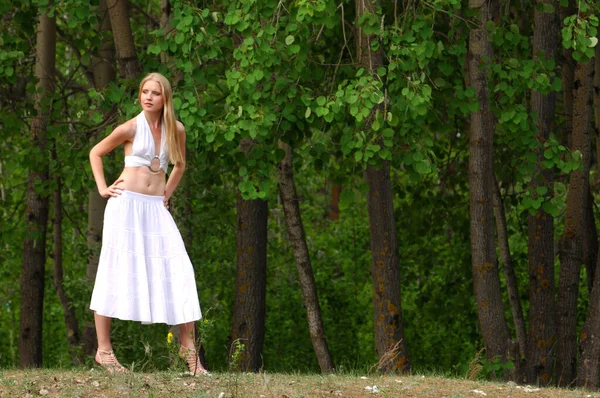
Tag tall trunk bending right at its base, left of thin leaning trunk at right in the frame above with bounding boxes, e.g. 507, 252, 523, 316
469, 0, 509, 362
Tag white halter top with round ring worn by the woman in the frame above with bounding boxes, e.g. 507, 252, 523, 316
125, 111, 169, 173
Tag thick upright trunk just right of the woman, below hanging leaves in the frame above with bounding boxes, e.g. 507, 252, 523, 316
231, 192, 268, 372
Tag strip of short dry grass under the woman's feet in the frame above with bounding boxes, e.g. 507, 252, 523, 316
0, 368, 600, 398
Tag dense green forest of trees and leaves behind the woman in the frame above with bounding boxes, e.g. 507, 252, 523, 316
0, 0, 600, 387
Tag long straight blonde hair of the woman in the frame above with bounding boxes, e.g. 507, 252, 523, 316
138, 72, 183, 164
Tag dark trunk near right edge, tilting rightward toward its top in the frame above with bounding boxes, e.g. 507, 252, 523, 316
556, 61, 594, 386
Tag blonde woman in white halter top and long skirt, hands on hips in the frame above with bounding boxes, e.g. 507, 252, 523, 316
90, 73, 207, 375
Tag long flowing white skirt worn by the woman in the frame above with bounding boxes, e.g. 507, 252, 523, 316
90, 191, 202, 325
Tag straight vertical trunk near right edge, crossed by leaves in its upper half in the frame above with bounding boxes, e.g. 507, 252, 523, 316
526, 0, 559, 385
